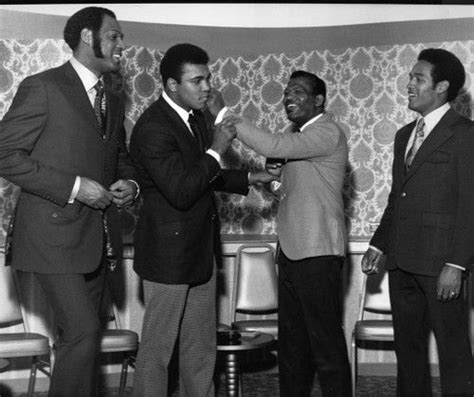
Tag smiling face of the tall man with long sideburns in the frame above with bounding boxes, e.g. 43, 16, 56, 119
89, 15, 125, 75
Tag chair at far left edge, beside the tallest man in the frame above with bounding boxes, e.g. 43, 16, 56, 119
0, 266, 50, 397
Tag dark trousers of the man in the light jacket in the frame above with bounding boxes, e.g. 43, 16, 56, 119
278, 251, 351, 397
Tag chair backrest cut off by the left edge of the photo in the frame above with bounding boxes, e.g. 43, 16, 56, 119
0, 254, 23, 328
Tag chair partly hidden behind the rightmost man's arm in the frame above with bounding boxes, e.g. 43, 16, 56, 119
351, 269, 394, 396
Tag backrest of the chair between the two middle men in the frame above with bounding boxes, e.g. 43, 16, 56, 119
232, 244, 278, 320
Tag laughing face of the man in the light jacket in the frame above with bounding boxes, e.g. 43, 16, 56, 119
283, 77, 324, 127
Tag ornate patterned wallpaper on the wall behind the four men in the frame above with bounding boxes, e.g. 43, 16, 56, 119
0, 39, 474, 246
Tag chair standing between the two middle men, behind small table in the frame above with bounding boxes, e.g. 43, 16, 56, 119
231, 244, 278, 339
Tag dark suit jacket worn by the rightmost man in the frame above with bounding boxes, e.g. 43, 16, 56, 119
371, 109, 474, 276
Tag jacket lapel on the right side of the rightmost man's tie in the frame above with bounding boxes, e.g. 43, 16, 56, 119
405, 109, 459, 179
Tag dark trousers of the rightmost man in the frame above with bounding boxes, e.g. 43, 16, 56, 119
389, 269, 474, 397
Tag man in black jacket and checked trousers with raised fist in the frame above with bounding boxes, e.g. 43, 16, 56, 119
130, 44, 273, 397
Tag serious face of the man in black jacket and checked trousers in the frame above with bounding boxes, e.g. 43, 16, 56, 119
167, 63, 211, 111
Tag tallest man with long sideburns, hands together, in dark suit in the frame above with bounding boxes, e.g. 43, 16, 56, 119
0, 7, 137, 397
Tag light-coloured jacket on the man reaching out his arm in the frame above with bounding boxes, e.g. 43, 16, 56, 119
237, 113, 348, 260
